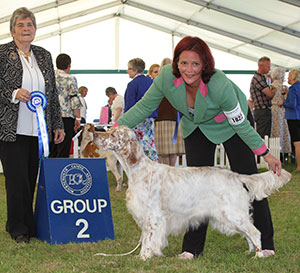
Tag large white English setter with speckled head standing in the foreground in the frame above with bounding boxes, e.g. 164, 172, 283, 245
94, 126, 291, 260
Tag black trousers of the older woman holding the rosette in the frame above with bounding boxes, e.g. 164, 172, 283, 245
0, 135, 39, 239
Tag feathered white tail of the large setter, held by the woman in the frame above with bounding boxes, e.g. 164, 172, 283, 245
239, 169, 292, 200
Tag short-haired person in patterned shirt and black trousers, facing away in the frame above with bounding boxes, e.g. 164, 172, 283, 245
49, 54, 81, 157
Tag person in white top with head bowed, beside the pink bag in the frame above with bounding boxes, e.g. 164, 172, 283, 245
105, 87, 124, 124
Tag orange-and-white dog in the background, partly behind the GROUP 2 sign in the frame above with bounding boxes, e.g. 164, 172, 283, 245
79, 123, 123, 191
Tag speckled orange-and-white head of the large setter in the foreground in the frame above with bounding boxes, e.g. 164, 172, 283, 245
94, 126, 142, 163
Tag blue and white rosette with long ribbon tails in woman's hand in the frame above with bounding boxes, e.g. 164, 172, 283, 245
26, 91, 49, 158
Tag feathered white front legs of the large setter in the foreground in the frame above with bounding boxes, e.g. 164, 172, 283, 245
140, 214, 168, 260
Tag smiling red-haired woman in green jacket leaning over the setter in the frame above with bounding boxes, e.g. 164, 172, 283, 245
116, 36, 281, 259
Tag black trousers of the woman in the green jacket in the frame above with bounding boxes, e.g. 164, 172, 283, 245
182, 129, 274, 256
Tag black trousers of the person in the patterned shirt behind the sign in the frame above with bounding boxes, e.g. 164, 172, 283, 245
49, 118, 75, 157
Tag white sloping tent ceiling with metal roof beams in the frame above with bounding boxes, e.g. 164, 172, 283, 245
0, 0, 300, 68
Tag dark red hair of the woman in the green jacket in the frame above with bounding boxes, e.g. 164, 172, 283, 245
172, 36, 215, 83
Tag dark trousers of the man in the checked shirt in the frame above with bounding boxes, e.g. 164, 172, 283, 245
253, 108, 272, 138
